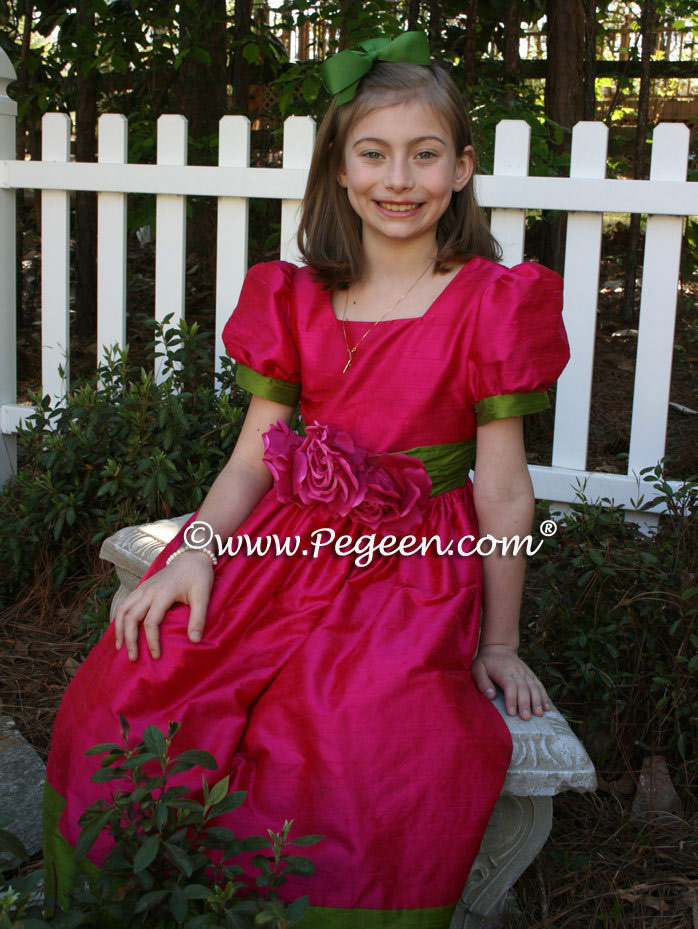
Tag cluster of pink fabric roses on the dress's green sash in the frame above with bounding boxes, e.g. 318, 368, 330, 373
263, 420, 431, 533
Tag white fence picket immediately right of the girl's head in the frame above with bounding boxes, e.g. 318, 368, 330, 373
486, 119, 531, 268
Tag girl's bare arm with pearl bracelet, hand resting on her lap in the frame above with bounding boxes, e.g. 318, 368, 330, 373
114, 396, 294, 661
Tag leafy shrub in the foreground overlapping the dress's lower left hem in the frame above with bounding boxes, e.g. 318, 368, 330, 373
0, 716, 322, 929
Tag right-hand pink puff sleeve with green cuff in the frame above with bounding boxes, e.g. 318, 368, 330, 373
468, 262, 569, 426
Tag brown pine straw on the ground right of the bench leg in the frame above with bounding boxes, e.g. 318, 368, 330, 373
511, 789, 698, 929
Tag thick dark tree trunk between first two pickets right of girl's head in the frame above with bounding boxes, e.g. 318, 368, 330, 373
542, 0, 585, 271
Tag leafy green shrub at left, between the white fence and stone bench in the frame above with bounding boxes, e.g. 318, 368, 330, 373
0, 317, 247, 606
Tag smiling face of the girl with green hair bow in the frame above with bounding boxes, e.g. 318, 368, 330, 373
337, 101, 474, 247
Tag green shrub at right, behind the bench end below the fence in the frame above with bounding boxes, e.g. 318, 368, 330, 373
528, 466, 698, 767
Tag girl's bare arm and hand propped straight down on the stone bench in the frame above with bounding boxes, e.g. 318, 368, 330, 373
472, 416, 550, 719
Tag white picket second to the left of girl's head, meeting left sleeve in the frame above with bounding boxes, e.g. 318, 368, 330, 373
215, 116, 250, 371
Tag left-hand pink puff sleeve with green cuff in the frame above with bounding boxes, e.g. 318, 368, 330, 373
223, 261, 301, 406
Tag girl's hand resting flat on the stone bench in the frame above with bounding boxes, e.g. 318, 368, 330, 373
471, 645, 550, 719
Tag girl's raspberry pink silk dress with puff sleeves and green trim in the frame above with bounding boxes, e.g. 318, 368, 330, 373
46, 258, 569, 929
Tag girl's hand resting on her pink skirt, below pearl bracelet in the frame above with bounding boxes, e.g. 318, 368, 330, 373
114, 551, 213, 661
